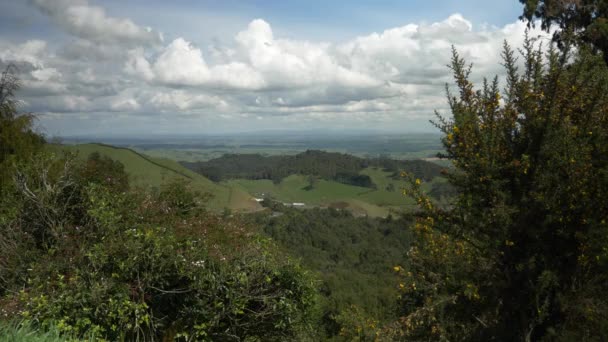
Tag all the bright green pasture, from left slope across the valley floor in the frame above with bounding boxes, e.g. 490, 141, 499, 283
50, 144, 441, 217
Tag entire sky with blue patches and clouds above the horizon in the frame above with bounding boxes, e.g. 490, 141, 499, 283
0, 0, 548, 136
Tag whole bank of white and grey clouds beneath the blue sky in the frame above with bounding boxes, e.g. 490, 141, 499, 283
0, 4, 549, 134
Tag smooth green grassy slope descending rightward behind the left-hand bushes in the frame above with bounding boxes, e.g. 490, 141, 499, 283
49, 144, 259, 211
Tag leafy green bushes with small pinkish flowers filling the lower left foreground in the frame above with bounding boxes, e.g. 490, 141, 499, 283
0, 155, 315, 341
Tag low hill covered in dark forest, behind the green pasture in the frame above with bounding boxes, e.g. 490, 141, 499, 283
182, 150, 442, 187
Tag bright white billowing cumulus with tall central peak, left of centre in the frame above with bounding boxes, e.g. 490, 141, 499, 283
125, 19, 382, 90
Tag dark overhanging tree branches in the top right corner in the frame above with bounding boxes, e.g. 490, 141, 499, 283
519, 0, 608, 65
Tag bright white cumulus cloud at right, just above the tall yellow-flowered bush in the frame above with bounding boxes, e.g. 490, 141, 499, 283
336, 14, 524, 84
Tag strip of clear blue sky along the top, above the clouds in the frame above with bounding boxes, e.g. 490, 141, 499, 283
98, 0, 522, 43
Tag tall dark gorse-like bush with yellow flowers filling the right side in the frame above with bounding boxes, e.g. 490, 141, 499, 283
395, 39, 608, 341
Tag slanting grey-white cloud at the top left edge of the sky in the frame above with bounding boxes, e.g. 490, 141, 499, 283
31, 0, 162, 45
